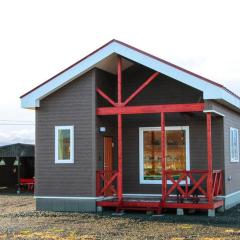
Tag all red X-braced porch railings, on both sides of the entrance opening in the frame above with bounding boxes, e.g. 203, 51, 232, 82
96, 170, 223, 203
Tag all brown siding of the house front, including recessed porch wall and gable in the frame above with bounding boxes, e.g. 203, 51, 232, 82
36, 63, 229, 196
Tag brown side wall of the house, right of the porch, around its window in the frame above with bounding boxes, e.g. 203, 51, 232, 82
207, 101, 240, 194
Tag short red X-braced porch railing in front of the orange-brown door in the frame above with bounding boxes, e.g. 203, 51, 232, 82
96, 170, 118, 196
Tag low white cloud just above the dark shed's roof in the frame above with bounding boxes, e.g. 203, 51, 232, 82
0, 129, 35, 146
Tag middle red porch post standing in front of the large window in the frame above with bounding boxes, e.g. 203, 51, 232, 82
161, 112, 167, 203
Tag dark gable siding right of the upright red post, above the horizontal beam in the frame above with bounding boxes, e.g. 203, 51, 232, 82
123, 66, 202, 105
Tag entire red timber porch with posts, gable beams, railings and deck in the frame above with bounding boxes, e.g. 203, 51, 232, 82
96, 57, 223, 213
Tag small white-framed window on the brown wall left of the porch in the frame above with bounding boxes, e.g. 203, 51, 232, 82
55, 126, 74, 163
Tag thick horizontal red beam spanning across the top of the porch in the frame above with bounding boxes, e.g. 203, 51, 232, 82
97, 103, 204, 115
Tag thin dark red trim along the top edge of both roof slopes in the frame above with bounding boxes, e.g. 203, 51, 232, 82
20, 39, 240, 99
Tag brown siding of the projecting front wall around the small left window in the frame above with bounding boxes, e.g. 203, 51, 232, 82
35, 71, 96, 196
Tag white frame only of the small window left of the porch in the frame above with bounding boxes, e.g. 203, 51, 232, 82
55, 126, 74, 163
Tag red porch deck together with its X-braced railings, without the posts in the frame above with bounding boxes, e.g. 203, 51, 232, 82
97, 170, 223, 214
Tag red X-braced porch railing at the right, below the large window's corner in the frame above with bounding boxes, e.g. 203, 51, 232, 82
165, 170, 223, 203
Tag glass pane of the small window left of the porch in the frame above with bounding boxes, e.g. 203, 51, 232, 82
58, 129, 70, 160
